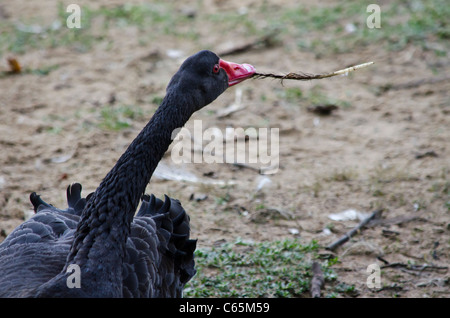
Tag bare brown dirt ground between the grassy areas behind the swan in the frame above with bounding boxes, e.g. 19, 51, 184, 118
0, 0, 450, 297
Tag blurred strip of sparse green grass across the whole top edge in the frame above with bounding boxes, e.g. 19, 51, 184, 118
0, 0, 450, 56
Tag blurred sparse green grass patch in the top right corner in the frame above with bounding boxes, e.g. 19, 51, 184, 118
276, 0, 450, 56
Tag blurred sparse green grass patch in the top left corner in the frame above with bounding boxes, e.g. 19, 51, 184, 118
0, 1, 196, 56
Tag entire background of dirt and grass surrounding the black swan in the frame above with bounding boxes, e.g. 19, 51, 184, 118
0, 0, 450, 297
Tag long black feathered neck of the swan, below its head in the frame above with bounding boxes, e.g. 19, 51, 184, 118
63, 92, 193, 295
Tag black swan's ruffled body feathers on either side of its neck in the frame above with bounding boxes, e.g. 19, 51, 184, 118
0, 184, 195, 297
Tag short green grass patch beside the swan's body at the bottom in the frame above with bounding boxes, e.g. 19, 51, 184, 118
184, 239, 337, 297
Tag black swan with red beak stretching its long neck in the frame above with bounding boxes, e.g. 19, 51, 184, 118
0, 50, 255, 297
